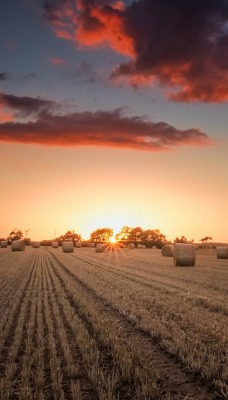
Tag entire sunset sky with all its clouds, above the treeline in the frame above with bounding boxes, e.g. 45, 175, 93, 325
0, 0, 228, 242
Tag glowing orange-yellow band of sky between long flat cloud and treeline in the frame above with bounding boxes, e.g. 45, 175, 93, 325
0, 144, 228, 242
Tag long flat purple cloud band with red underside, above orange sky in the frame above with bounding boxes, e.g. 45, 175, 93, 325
0, 94, 212, 152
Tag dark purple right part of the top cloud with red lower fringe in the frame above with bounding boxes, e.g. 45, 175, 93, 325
113, 0, 228, 101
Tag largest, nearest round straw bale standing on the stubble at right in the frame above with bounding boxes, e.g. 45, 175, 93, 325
173, 243, 196, 267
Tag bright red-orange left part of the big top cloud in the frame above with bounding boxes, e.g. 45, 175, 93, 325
44, 0, 134, 56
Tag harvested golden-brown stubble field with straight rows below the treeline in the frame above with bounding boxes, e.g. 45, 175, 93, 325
0, 247, 228, 400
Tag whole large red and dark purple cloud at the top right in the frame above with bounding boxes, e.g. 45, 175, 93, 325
44, 0, 228, 102
